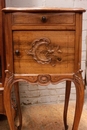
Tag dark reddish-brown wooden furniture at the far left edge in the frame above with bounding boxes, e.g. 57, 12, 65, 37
0, 0, 5, 114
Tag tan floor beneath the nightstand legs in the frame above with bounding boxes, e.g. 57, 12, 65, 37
0, 102, 87, 130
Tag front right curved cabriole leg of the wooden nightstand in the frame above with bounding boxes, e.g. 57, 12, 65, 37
72, 72, 84, 130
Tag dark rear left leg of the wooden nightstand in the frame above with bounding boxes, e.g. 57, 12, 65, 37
14, 82, 22, 130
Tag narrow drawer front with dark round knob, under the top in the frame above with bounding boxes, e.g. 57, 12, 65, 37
12, 13, 75, 26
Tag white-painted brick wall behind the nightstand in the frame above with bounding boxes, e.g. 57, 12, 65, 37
6, 0, 87, 104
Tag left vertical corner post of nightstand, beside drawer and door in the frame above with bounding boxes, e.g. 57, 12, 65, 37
4, 14, 13, 71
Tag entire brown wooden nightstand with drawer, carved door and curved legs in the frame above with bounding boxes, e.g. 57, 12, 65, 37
3, 8, 85, 130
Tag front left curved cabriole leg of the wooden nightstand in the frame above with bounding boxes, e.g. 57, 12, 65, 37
4, 71, 18, 130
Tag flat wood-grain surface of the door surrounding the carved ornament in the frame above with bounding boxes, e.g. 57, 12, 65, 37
13, 31, 75, 74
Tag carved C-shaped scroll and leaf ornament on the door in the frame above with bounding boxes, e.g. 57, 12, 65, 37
25, 38, 62, 66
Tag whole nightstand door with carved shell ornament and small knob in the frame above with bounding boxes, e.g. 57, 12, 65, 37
13, 31, 75, 74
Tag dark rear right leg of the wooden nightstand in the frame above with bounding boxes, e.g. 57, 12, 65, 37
63, 81, 71, 130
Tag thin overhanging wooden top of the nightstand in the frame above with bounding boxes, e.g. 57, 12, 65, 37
3, 7, 86, 13
